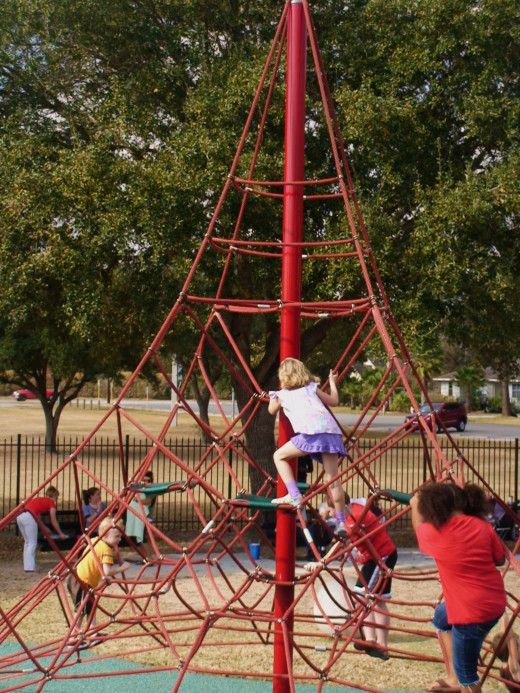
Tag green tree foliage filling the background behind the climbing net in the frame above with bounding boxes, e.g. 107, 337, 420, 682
0, 0, 520, 444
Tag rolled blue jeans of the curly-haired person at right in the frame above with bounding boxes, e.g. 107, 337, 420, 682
432, 602, 500, 686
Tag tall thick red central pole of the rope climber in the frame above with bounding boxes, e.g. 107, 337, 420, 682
273, 0, 307, 693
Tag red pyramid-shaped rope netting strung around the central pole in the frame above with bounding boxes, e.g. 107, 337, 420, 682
0, 0, 519, 691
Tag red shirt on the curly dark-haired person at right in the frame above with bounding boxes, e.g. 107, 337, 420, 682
416, 515, 506, 624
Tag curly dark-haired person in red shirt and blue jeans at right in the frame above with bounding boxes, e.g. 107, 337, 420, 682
410, 482, 506, 693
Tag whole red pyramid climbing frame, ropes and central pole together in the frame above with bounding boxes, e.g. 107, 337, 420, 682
0, 5, 520, 693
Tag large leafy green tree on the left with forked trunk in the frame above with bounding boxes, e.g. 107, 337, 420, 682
0, 0, 195, 445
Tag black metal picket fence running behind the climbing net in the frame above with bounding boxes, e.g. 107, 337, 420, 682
0, 435, 519, 534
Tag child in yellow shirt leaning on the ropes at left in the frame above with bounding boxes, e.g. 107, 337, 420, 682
67, 516, 130, 647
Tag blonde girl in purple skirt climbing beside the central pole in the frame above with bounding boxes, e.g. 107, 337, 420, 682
269, 358, 347, 536
